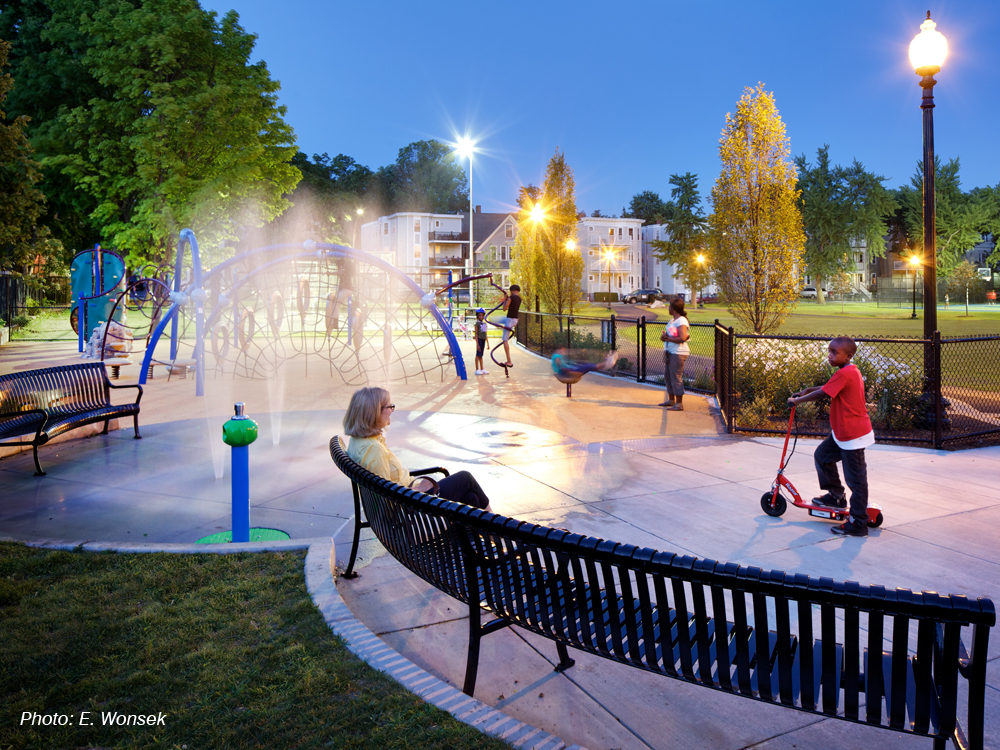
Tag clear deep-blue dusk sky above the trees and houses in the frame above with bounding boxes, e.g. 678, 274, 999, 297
204, 0, 1000, 214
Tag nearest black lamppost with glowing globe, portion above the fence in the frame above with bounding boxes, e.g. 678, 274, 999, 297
910, 11, 948, 340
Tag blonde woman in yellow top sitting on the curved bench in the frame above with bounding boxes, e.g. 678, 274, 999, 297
344, 387, 492, 512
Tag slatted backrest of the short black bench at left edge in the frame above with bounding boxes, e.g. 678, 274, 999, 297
0, 362, 110, 415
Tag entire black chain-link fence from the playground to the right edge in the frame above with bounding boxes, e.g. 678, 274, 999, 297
516, 310, 1000, 448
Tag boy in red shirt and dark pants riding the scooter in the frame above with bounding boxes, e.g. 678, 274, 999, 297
788, 336, 875, 536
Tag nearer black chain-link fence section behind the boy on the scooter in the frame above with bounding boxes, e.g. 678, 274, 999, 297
715, 325, 1000, 448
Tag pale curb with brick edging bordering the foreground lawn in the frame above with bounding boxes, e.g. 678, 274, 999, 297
7, 537, 587, 750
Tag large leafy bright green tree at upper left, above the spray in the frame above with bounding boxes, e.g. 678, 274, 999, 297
46, 0, 301, 264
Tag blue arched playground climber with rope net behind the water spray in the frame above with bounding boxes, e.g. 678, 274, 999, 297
120, 229, 466, 396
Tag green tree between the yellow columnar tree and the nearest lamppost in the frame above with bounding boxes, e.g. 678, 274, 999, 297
795, 145, 897, 305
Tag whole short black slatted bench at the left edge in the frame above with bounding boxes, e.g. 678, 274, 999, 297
0, 362, 142, 476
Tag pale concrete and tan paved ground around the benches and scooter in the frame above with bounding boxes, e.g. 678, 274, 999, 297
0, 344, 1000, 749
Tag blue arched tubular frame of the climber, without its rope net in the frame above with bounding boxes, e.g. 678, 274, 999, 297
139, 229, 468, 396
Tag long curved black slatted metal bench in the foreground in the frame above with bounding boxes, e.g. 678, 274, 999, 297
330, 437, 996, 749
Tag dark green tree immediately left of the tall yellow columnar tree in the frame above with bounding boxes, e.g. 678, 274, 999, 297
651, 172, 708, 294
